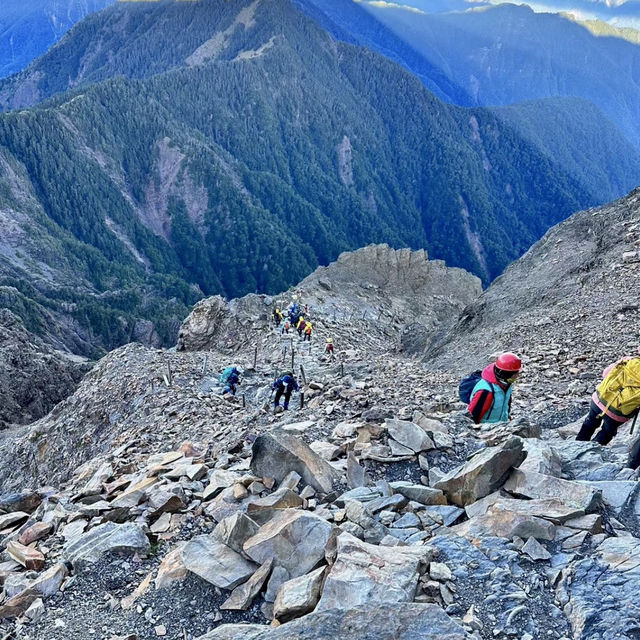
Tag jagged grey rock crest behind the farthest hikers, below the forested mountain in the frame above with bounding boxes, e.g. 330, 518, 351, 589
178, 244, 482, 353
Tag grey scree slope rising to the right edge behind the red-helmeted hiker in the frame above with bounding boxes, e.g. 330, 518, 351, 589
424, 185, 640, 424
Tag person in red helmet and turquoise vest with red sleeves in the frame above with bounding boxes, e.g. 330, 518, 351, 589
461, 353, 522, 424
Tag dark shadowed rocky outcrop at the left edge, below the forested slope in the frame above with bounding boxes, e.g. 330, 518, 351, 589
0, 309, 90, 428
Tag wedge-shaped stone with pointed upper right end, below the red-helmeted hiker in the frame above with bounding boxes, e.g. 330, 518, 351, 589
435, 436, 525, 507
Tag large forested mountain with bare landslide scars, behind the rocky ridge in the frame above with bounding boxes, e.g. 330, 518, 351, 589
0, 0, 640, 352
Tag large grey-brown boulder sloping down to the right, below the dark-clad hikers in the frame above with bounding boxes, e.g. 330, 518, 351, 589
251, 434, 340, 493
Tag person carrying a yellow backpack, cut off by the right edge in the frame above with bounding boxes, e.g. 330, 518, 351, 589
576, 347, 640, 469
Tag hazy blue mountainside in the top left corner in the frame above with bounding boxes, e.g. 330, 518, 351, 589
0, 0, 115, 78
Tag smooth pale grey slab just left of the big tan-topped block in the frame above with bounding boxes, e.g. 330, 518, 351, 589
182, 535, 258, 589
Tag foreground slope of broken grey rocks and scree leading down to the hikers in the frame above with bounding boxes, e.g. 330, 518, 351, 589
0, 248, 640, 640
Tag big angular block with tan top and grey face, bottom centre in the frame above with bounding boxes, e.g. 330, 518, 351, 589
244, 509, 333, 578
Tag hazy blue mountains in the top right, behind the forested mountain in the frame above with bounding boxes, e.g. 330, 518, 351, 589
295, 0, 640, 147
